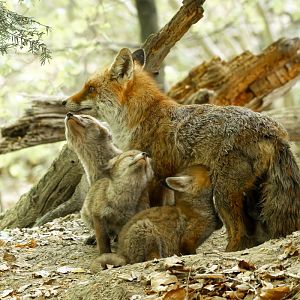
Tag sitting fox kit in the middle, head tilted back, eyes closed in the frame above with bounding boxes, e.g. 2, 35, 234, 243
81, 150, 153, 254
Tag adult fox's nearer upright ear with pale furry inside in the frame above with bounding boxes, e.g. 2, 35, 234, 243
109, 48, 134, 83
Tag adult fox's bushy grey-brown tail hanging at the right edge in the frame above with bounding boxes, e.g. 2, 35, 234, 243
261, 142, 300, 238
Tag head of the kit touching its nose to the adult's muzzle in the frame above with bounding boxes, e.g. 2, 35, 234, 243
65, 113, 112, 152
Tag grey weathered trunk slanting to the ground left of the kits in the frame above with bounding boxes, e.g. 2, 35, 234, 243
0, 146, 85, 229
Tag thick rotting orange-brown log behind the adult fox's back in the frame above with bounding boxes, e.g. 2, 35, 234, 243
168, 38, 300, 111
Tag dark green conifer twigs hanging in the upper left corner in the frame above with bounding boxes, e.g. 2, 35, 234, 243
0, 1, 51, 65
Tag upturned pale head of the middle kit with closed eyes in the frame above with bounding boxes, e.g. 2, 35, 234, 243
106, 150, 153, 187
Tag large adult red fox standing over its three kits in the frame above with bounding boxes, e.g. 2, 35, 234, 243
63, 48, 300, 251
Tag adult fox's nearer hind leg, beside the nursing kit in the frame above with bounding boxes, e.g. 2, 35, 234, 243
213, 153, 257, 251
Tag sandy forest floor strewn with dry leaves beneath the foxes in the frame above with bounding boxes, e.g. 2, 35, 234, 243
0, 215, 300, 300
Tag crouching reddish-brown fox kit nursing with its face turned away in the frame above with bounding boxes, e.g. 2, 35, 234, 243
93, 166, 222, 267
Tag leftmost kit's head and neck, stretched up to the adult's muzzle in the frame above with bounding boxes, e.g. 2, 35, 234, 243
65, 113, 122, 185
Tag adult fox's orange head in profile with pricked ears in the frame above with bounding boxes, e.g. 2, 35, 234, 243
62, 48, 147, 121
